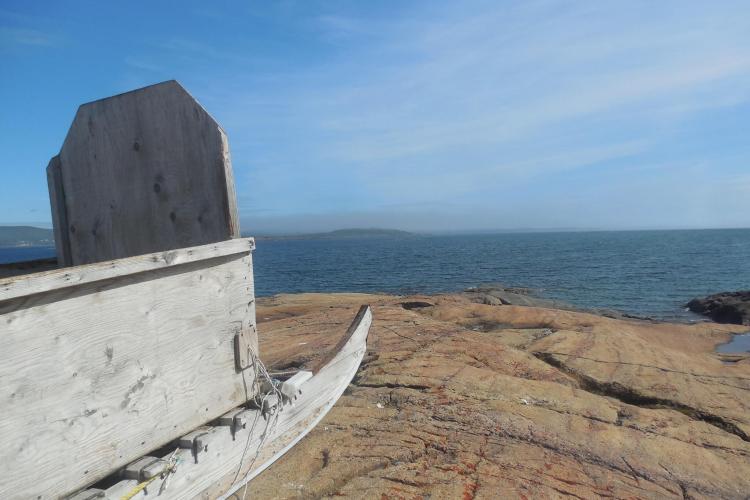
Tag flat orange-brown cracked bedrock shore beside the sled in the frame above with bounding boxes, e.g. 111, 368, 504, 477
247, 294, 750, 500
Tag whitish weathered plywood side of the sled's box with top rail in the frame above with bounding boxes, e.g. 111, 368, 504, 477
0, 239, 257, 499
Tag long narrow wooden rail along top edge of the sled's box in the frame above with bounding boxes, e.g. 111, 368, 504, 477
0, 238, 255, 300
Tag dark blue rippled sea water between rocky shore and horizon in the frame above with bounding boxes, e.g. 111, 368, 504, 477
0, 229, 750, 321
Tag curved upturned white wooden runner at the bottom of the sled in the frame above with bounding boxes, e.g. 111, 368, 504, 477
75, 306, 372, 500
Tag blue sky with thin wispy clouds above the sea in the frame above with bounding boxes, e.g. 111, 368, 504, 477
0, 0, 750, 232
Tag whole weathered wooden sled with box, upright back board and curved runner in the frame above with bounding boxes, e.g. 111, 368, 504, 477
0, 81, 372, 500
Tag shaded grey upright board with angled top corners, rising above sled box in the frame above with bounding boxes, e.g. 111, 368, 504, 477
47, 81, 240, 266
